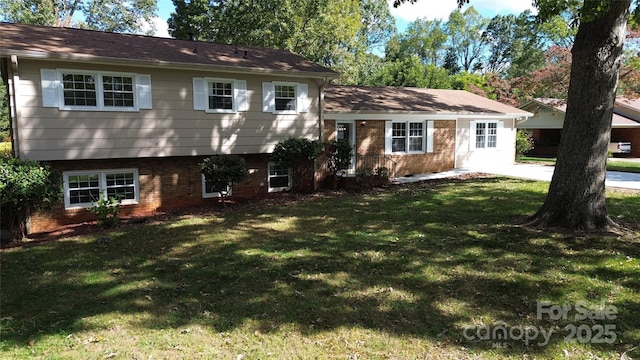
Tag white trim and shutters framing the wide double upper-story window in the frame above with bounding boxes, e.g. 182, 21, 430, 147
41, 69, 151, 112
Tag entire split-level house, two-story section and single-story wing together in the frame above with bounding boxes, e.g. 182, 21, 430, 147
0, 23, 533, 236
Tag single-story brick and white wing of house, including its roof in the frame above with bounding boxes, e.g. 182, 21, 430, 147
323, 85, 533, 176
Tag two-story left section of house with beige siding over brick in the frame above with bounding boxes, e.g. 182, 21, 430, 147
0, 23, 337, 232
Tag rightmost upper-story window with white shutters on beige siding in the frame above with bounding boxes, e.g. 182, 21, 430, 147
262, 81, 309, 114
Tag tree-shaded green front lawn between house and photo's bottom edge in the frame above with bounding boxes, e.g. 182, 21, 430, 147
0, 178, 640, 359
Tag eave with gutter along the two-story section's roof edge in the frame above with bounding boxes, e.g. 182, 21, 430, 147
0, 48, 340, 78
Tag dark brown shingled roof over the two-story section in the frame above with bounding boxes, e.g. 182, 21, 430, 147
0, 23, 338, 77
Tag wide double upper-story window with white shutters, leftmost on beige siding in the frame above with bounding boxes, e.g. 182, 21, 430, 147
41, 69, 152, 111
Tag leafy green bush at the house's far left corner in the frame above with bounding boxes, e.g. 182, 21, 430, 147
0, 158, 62, 240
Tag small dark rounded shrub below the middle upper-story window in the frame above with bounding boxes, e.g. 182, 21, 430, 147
199, 155, 248, 206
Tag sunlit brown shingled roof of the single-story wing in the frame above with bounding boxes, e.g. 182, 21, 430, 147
325, 85, 531, 116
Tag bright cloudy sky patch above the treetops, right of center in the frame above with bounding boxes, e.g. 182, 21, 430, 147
387, 0, 536, 21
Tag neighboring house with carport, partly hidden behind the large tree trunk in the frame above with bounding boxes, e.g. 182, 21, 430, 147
518, 97, 640, 157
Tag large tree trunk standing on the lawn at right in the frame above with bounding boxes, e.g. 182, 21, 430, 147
530, 0, 631, 231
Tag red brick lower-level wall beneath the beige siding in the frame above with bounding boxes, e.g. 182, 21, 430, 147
30, 154, 300, 233
